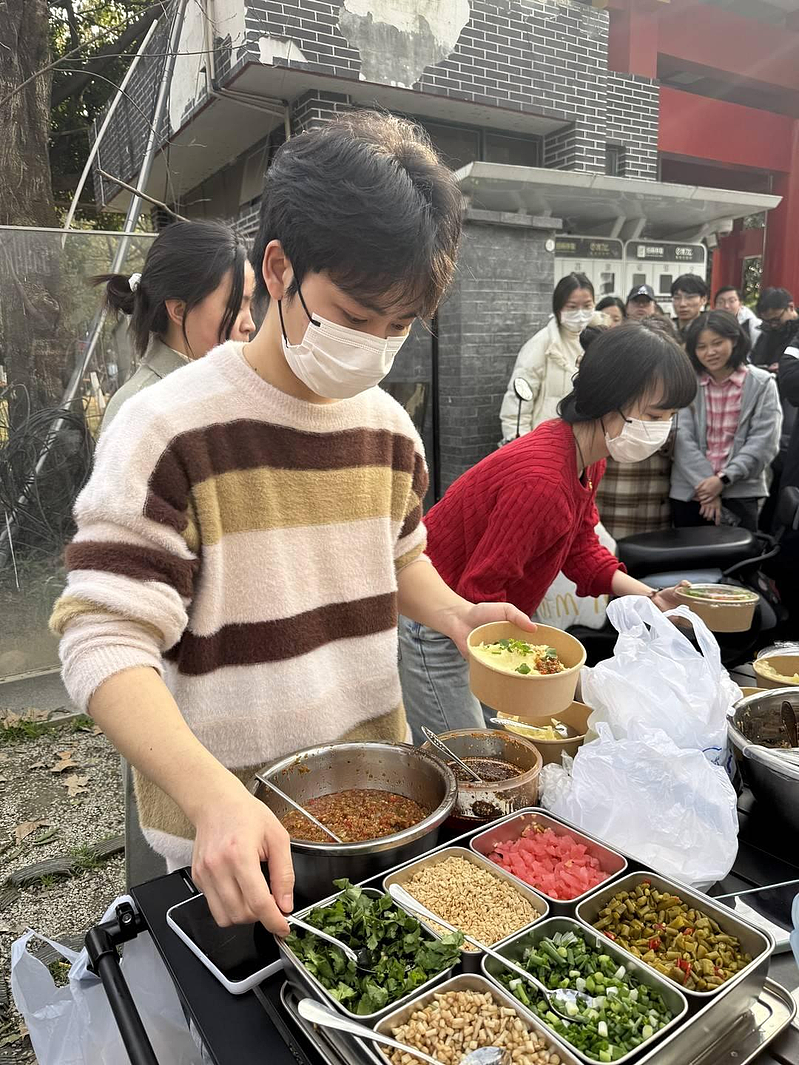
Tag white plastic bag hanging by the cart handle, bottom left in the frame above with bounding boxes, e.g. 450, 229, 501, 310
11, 896, 201, 1065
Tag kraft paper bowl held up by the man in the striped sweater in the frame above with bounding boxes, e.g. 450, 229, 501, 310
467, 621, 586, 723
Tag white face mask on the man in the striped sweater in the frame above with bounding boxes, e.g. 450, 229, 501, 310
277, 293, 408, 399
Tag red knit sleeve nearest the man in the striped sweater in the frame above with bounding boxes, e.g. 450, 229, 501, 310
457, 481, 571, 603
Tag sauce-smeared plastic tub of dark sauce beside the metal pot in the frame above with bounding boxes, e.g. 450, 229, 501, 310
422, 728, 542, 831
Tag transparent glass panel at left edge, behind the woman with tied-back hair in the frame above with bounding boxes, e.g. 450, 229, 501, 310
0, 227, 156, 677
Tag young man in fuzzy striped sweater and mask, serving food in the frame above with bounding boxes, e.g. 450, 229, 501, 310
51, 113, 533, 934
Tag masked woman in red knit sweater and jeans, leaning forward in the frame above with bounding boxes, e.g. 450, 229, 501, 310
400, 320, 697, 742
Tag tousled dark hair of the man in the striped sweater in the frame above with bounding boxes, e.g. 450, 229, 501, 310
250, 111, 461, 317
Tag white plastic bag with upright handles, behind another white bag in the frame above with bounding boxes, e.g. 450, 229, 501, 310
581, 595, 743, 765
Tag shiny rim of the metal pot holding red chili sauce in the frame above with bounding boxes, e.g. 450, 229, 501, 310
256, 741, 458, 857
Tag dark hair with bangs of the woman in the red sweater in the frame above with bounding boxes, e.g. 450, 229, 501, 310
558, 318, 697, 425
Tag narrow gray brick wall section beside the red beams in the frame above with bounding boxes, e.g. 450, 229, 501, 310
605, 70, 661, 181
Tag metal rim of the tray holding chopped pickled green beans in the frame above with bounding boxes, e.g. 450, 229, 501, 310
576, 872, 774, 1010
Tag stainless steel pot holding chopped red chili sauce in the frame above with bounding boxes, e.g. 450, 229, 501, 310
255, 743, 458, 902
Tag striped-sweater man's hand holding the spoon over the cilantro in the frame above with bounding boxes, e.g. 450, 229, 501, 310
192, 777, 294, 935
